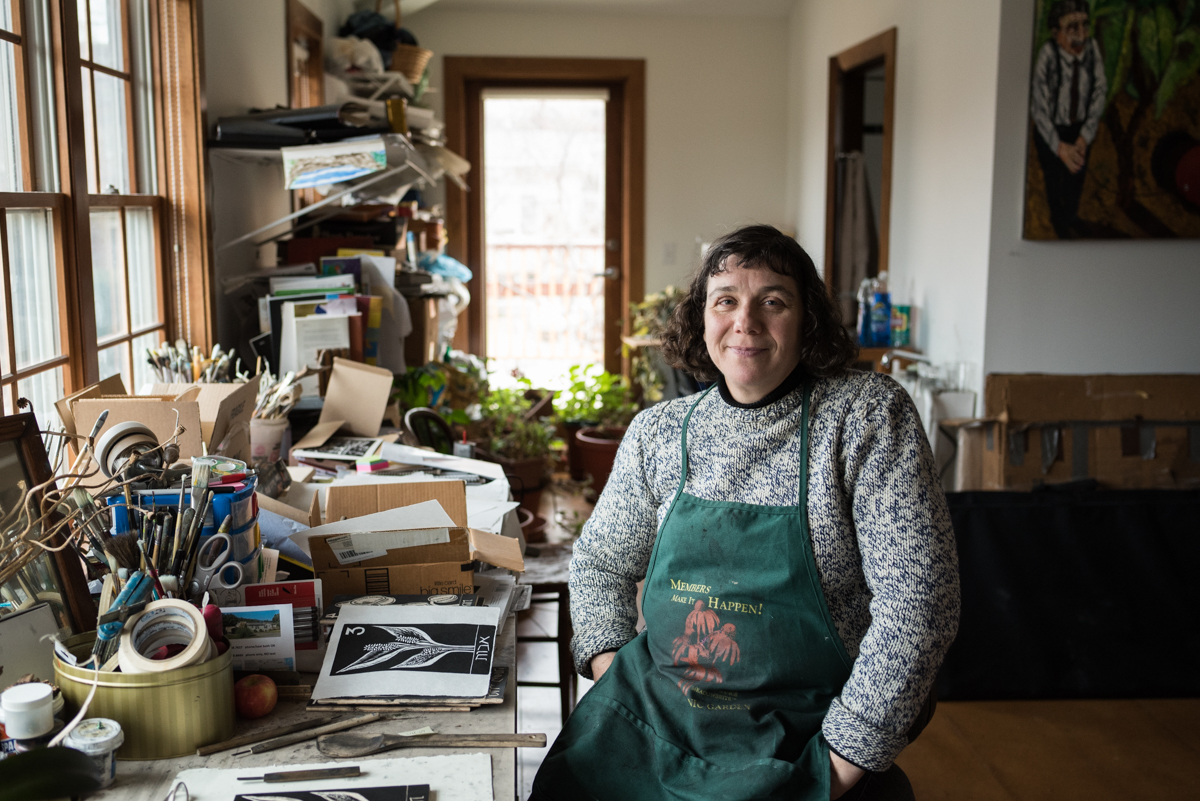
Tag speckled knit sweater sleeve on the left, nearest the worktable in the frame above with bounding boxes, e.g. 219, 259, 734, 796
570, 408, 660, 679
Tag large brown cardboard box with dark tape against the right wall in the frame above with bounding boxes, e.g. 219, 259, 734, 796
964, 374, 1200, 490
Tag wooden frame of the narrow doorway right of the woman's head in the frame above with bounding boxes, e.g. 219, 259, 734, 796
824, 28, 896, 291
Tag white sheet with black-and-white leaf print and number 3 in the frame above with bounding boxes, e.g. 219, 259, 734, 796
312, 606, 500, 699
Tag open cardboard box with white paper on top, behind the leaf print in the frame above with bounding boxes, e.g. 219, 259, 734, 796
295, 481, 524, 597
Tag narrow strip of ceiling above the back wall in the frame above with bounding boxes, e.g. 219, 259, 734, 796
403, 0, 794, 19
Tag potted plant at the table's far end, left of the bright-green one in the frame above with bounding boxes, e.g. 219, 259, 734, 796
479, 379, 554, 525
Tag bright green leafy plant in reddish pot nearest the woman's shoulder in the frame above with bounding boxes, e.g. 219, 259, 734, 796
554, 365, 637, 496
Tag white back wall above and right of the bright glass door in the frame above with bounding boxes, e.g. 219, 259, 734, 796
404, 6, 791, 293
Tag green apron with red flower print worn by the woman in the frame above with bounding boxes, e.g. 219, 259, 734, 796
532, 386, 851, 801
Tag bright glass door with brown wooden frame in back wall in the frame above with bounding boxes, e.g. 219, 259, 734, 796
444, 56, 646, 385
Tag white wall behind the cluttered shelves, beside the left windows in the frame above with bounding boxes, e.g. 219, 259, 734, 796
204, 0, 352, 344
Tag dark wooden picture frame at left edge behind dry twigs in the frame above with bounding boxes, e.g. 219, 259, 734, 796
0, 414, 96, 633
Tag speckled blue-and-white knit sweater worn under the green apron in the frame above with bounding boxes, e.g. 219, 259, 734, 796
570, 371, 959, 771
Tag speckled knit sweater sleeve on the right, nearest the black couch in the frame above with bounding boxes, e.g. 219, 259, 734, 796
822, 377, 959, 771
